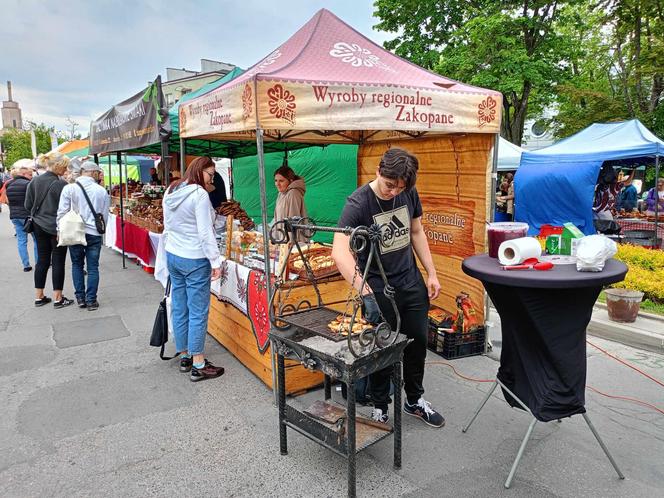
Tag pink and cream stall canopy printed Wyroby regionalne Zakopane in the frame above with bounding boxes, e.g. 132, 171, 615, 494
179, 9, 502, 145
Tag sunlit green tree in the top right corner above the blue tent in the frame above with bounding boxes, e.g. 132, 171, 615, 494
554, 0, 664, 138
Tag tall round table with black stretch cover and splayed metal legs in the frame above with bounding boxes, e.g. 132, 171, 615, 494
462, 254, 627, 487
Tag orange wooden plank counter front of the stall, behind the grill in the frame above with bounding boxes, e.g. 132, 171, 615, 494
208, 280, 349, 394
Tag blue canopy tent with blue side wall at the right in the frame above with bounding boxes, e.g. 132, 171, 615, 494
514, 119, 664, 235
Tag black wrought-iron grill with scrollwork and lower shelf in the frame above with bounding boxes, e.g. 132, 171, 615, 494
269, 218, 409, 497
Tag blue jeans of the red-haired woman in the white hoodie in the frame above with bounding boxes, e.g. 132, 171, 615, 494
166, 252, 212, 355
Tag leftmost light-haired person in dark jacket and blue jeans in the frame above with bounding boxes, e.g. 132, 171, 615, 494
5, 159, 37, 272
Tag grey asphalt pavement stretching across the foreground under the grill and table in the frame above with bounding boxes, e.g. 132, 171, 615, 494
0, 215, 664, 498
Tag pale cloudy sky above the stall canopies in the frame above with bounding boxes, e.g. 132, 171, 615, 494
0, 0, 392, 136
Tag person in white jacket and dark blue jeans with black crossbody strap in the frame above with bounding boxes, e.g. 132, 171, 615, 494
57, 161, 111, 311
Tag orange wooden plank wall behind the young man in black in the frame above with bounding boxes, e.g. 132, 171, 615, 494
357, 134, 494, 320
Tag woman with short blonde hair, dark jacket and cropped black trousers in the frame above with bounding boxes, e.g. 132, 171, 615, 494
25, 152, 74, 309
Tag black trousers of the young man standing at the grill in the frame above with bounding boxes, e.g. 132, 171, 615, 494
370, 275, 429, 412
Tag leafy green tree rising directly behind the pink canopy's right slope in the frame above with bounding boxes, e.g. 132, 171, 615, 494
374, 0, 587, 145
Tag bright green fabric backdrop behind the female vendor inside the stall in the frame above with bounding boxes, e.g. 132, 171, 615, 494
232, 145, 357, 242
